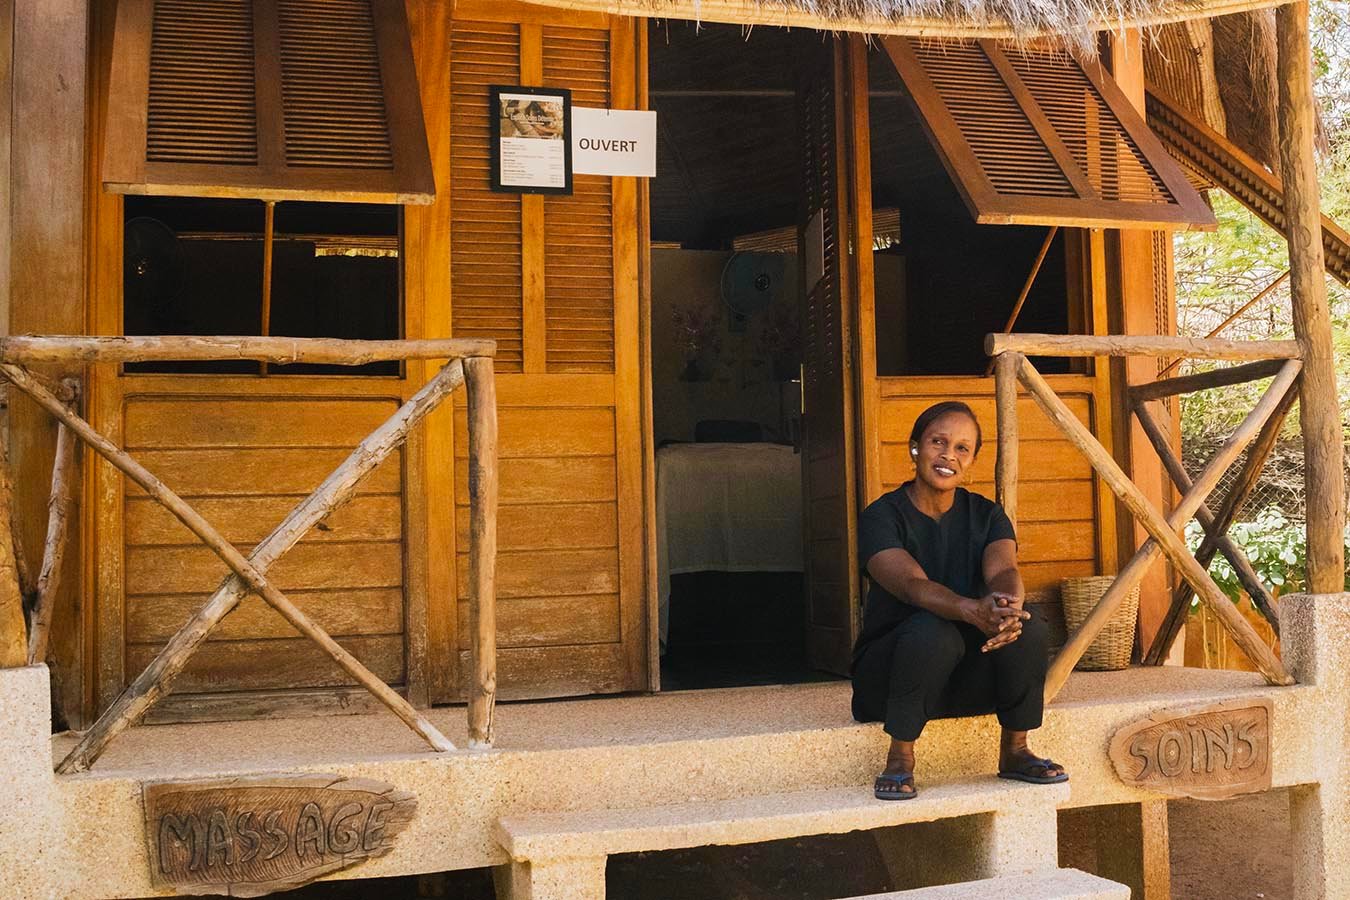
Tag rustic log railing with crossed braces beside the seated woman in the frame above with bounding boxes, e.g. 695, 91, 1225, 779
986, 335, 1303, 700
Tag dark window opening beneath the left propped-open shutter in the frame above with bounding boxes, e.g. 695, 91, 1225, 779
123, 197, 402, 375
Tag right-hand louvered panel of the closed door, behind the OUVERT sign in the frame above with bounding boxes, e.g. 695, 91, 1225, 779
544, 26, 614, 372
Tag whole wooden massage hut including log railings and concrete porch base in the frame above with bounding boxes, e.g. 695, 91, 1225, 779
0, 0, 1350, 897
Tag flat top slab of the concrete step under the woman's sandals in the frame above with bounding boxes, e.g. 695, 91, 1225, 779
495, 776, 1069, 862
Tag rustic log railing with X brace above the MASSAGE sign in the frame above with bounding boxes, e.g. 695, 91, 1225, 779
0, 336, 497, 773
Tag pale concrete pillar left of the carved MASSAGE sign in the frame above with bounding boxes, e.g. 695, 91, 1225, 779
0, 665, 74, 897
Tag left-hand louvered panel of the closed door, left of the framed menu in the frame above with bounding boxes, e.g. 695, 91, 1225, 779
450, 22, 524, 372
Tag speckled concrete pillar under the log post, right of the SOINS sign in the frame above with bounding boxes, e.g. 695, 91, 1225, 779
1280, 594, 1350, 900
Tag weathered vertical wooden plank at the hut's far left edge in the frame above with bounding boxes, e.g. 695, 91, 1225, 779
7, 0, 95, 716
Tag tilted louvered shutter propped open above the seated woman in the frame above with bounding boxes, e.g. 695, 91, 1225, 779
883, 36, 1215, 229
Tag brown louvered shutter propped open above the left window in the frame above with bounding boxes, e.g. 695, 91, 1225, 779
103, 0, 435, 202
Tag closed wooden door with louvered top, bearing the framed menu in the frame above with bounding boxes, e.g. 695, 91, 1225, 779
433, 0, 648, 700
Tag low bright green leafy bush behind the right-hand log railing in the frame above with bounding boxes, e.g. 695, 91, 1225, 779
1185, 509, 1350, 610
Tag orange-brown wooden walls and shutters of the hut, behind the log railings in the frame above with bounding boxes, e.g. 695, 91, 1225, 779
9, 0, 1339, 725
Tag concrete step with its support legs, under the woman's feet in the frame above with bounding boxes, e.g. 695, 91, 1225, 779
497, 776, 1069, 900
